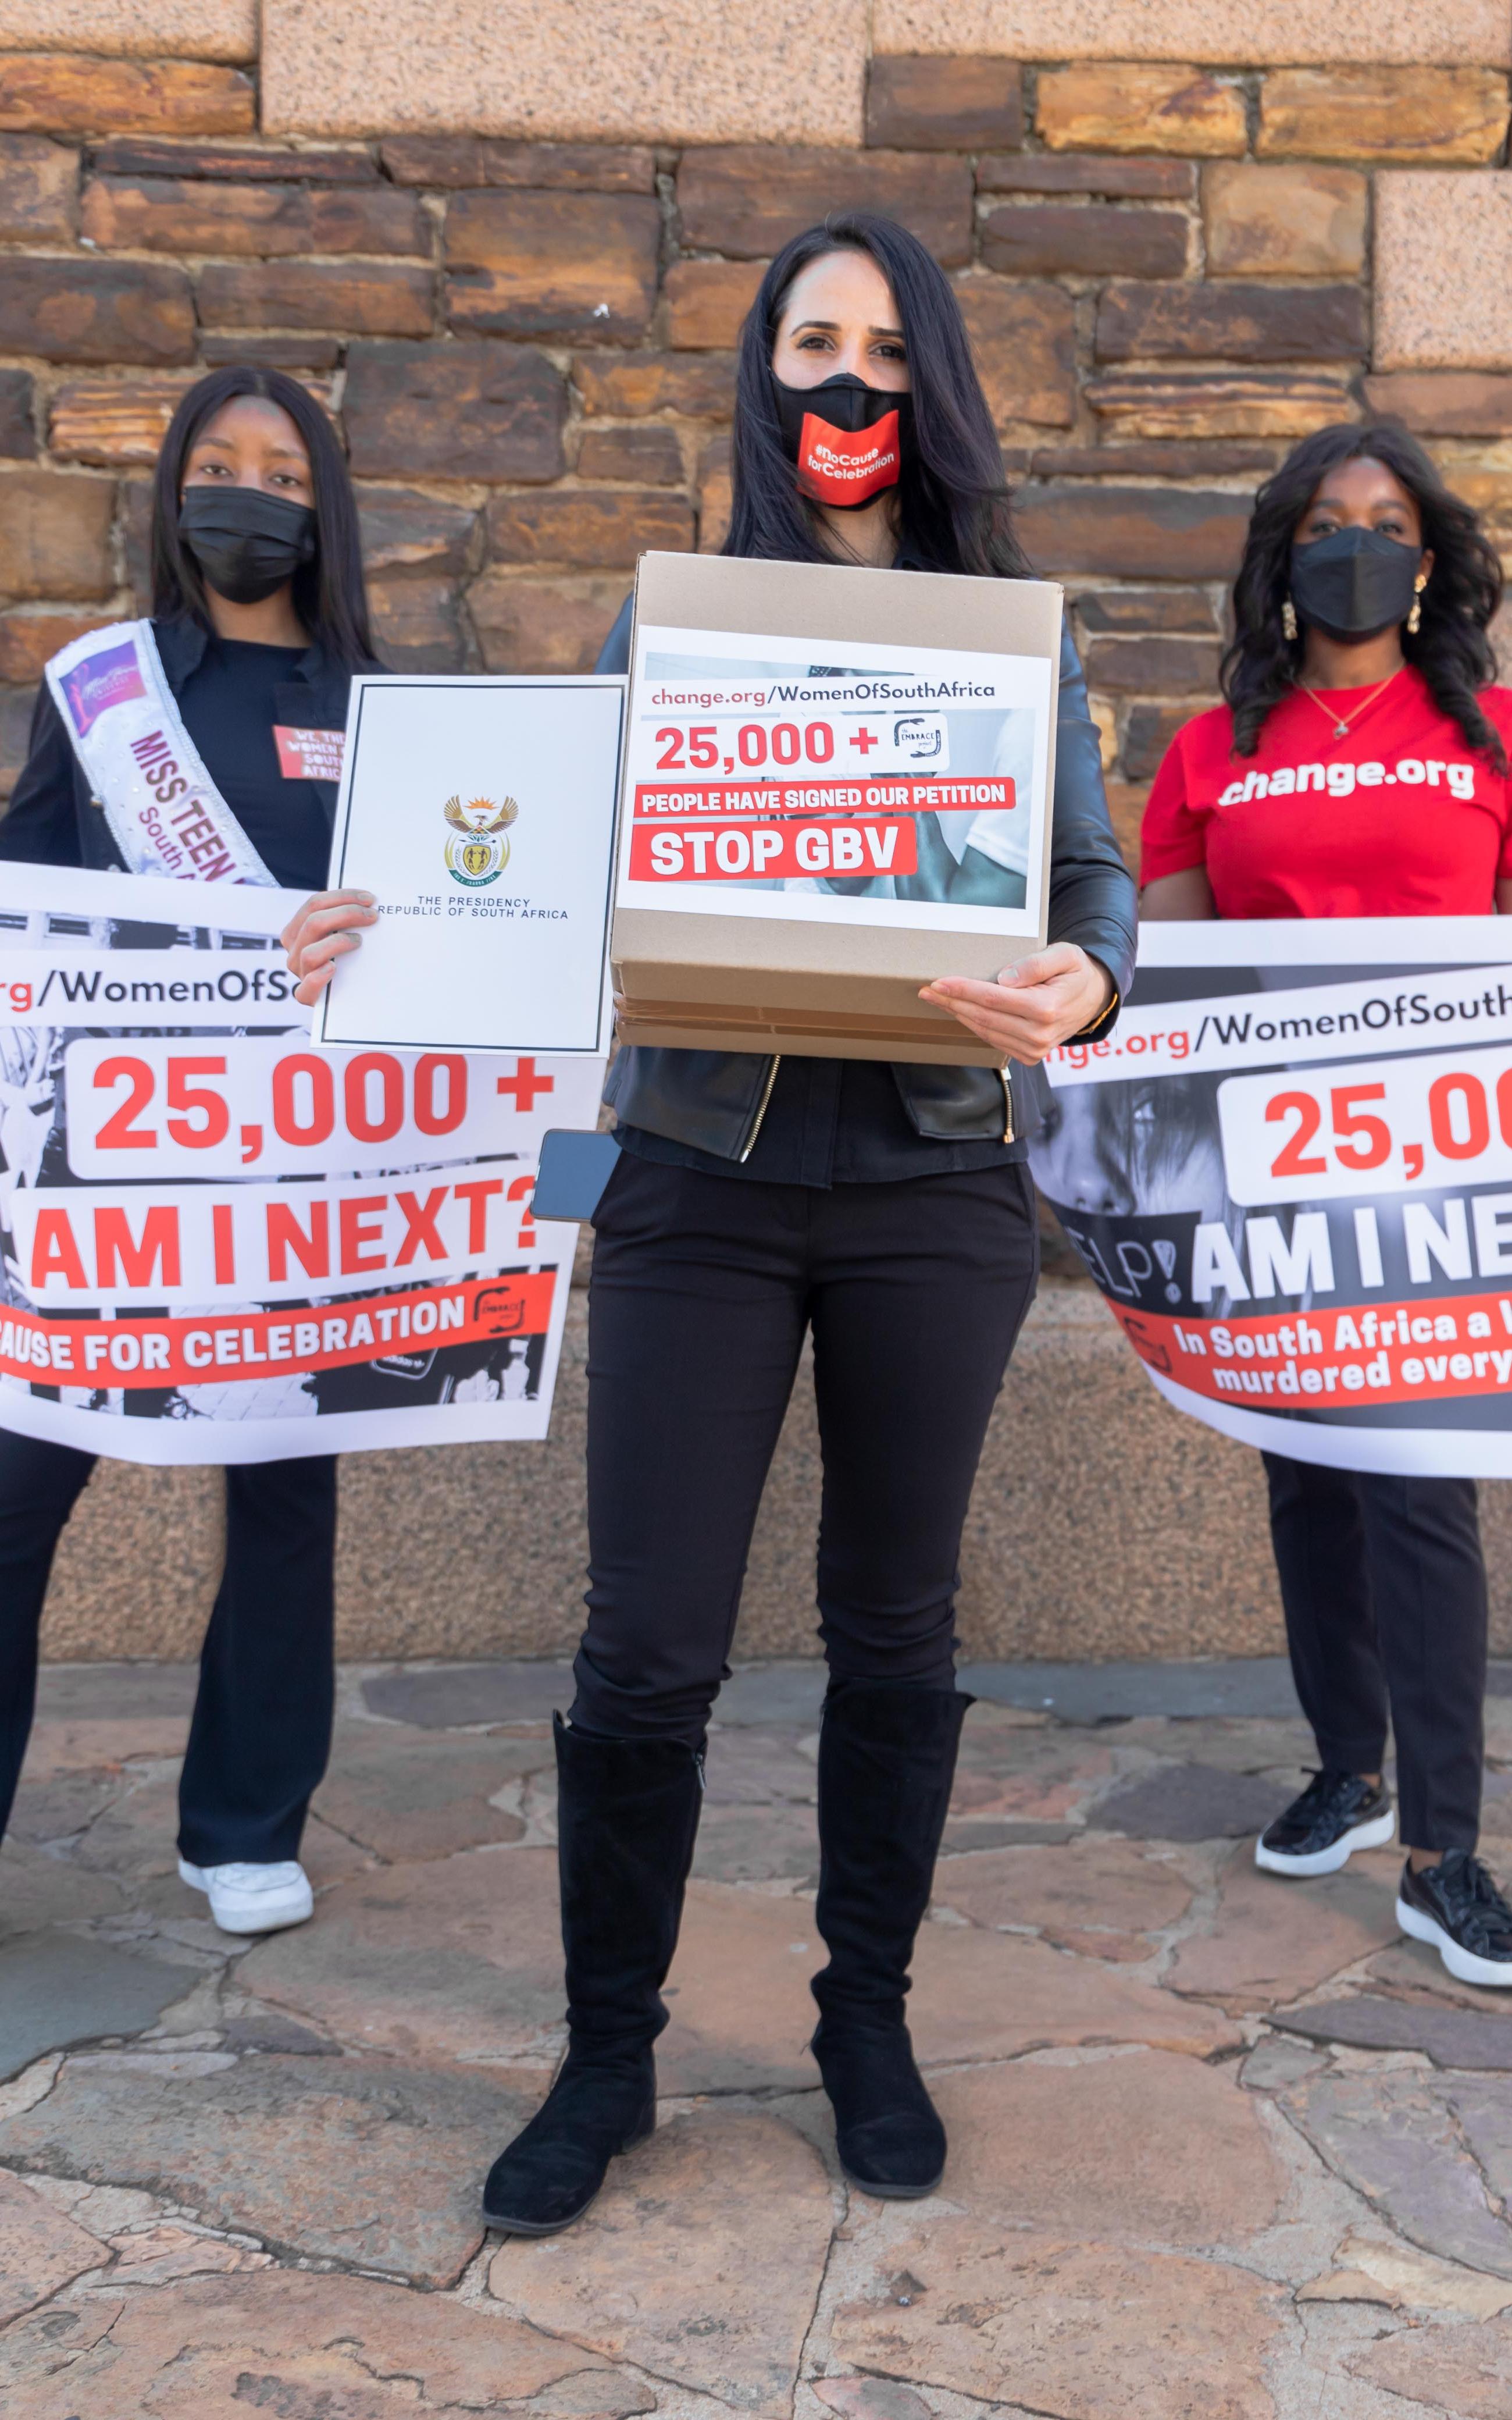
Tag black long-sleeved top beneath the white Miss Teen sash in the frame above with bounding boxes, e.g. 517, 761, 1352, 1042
0, 620, 382, 891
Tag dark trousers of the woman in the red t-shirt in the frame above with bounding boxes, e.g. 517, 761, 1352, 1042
1265, 1454, 1485, 1849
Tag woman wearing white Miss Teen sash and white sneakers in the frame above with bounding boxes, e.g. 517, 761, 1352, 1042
0, 368, 375, 1934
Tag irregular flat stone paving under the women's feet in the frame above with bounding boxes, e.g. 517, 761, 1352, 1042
0, 1665, 1512, 2420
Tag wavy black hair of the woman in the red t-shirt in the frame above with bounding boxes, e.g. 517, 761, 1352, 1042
1219, 421, 1507, 772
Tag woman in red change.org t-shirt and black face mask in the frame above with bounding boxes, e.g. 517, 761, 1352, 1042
1139, 424, 1512, 1984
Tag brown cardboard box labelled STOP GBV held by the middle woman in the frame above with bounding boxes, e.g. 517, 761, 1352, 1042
609, 554, 1062, 1067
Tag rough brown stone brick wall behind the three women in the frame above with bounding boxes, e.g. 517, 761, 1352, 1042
0, 30, 1512, 881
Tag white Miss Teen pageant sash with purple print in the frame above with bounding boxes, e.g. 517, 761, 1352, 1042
46, 622, 276, 888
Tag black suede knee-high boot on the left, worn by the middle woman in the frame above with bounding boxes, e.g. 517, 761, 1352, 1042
484, 1718, 704, 2236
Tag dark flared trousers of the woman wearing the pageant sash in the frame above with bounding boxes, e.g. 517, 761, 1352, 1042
0, 1430, 336, 1866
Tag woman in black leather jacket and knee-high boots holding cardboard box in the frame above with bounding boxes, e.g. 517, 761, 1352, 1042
290, 215, 1135, 2234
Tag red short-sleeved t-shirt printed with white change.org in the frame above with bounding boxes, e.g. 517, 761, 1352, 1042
1139, 666, 1512, 917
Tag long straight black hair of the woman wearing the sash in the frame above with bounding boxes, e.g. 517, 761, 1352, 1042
152, 363, 375, 668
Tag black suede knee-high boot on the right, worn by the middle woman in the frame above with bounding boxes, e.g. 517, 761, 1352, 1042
813, 1682, 970, 2200
